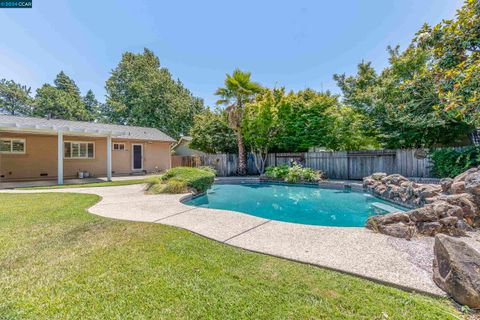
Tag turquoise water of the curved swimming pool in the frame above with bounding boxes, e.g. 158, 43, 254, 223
186, 183, 405, 227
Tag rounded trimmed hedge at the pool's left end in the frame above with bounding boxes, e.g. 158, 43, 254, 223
147, 167, 215, 193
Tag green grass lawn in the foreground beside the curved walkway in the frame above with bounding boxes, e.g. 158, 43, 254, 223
0, 193, 460, 319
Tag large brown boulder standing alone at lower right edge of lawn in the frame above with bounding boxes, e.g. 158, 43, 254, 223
433, 234, 480, 308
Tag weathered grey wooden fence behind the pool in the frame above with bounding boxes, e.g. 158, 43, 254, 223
172, 149, 432, 180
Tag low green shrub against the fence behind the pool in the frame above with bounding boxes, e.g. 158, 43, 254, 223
265, 162, 324, 183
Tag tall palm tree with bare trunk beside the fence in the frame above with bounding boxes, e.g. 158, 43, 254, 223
215, 69, 262, 175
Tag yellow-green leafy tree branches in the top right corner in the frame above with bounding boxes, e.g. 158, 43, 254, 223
414, 0, 480, 121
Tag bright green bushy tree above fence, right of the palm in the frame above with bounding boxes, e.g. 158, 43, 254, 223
273, 89, 378, 152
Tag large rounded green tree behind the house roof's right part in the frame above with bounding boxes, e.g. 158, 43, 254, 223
104, 49, 204, 138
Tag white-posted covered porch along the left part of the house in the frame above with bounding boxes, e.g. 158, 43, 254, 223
0, 122, 125, 185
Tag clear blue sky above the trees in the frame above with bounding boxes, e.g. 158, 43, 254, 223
0, 0, 462, 106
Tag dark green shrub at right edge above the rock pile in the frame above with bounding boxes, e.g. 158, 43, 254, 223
430, 146, 480, 178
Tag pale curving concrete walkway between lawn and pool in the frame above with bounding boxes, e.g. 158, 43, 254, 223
1, 185, 443, 295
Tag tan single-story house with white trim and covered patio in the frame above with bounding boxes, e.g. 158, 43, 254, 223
0, 115, 175, 184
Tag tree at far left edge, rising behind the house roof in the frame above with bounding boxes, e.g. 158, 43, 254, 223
0, 79, 32, 115
